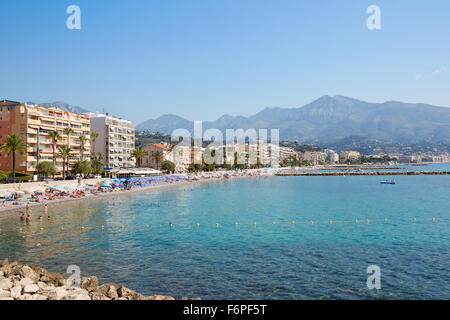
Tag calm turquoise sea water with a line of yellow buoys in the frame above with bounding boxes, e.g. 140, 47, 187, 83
0, 170, 450, 299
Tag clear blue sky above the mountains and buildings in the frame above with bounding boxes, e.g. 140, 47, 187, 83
0, 0, 450, 124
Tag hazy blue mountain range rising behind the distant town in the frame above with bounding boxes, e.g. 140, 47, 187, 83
136, 96, 450, 144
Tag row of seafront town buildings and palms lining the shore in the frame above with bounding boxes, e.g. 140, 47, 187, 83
0, 100, 450, 181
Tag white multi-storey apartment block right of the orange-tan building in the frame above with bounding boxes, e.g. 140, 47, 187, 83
88, 113, 135, 171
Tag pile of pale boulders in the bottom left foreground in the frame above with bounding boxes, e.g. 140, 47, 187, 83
0, 259, 198, 300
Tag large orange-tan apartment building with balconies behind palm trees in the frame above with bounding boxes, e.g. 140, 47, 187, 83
0, 100, 91, 173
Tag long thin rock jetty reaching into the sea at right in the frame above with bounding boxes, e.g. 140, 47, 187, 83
275, 171, 450, 177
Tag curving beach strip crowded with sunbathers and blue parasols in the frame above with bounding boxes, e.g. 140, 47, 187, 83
0, 169, 273, 215
